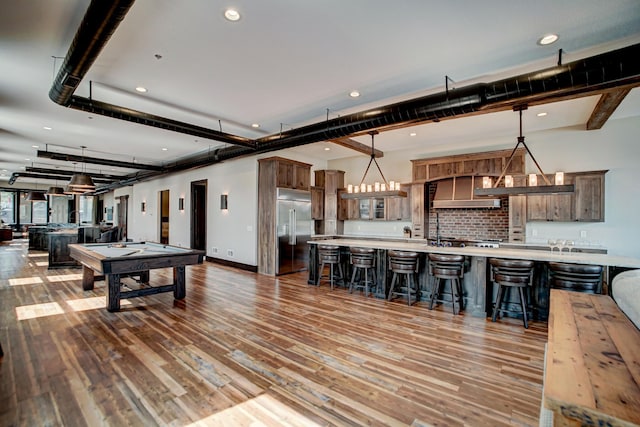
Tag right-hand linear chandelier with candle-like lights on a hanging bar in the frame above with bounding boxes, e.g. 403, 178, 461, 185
473, 104, 574, 196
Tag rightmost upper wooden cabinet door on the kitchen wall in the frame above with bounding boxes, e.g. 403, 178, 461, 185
574, 172, 604, 222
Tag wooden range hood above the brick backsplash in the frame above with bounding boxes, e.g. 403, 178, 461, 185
433, 176, 500, 209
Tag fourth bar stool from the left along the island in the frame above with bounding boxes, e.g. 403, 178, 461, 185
429, 253, 464, 314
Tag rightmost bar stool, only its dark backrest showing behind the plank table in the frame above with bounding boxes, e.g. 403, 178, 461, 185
549, 262, 602, 294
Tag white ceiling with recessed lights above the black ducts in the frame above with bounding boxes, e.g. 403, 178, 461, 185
0, 0, 640, 187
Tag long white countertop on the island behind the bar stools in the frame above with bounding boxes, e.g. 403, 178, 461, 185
308, 239, 640, 268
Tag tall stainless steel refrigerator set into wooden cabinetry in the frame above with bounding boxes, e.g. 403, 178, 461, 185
276, 188, 313, 274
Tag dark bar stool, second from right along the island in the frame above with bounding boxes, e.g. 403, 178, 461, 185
489, 258, 533, 329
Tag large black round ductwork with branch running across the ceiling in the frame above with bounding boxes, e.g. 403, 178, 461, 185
49, 0, 640, 193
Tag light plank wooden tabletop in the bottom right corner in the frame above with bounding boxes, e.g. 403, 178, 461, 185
543, 289, 640, 426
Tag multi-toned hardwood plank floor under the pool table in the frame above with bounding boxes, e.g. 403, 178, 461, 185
0, 240, 547, 427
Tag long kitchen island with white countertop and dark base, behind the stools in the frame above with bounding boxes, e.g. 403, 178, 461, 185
308, 238, 640, 320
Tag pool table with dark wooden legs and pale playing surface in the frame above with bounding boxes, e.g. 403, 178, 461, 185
69, 242, 204, 311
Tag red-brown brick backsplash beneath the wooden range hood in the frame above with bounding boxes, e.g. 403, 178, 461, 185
427, 186, 509, 241
